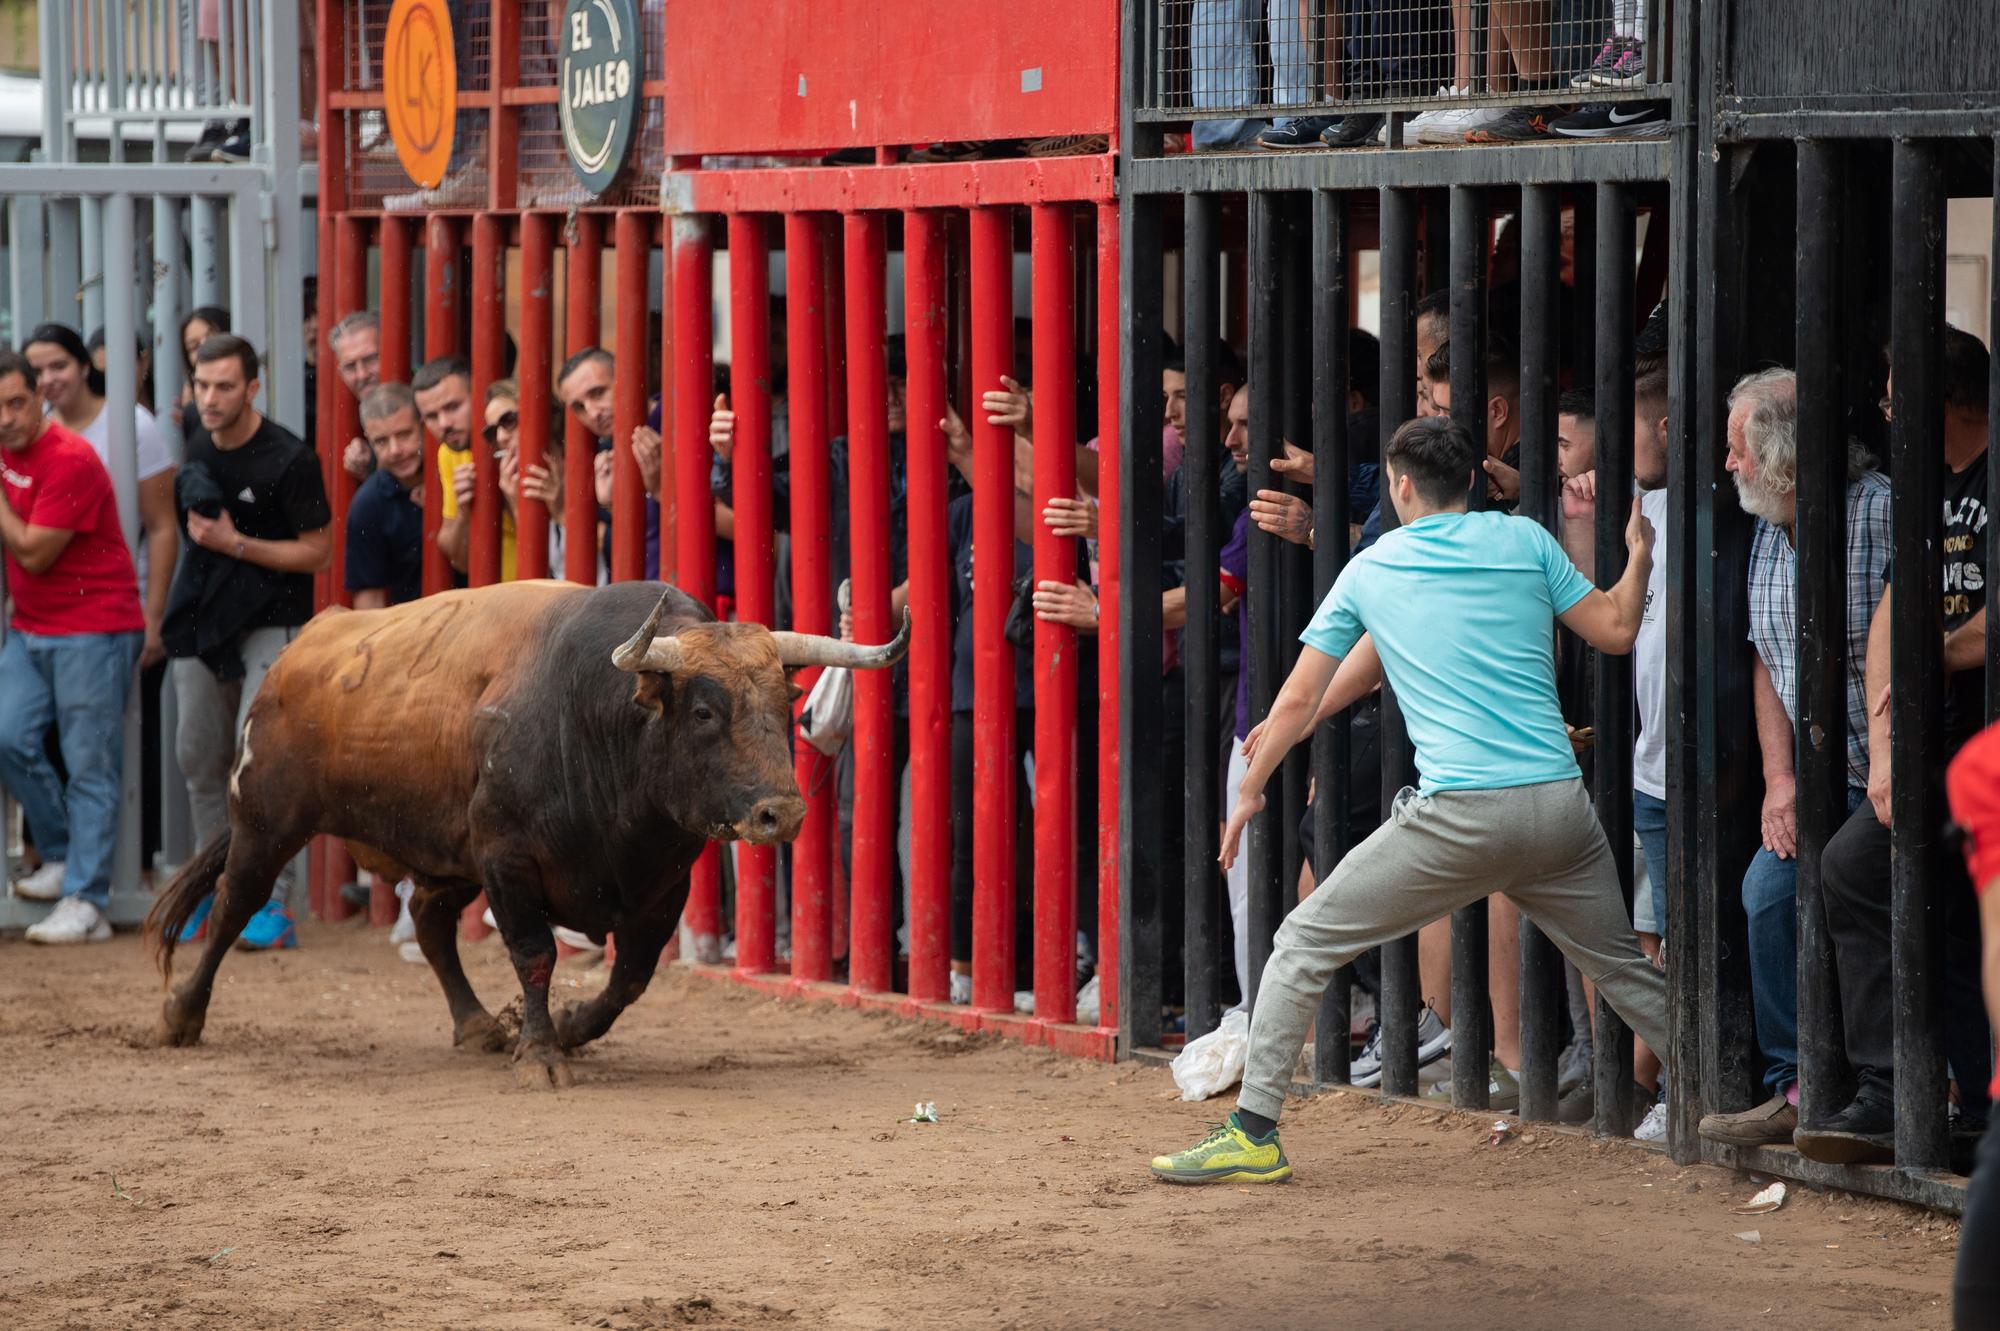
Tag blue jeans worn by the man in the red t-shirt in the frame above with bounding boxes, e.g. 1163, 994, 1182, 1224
0, 630, 140, 911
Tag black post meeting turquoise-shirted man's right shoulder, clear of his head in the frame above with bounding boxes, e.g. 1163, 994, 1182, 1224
1520, 186, 1566, 1121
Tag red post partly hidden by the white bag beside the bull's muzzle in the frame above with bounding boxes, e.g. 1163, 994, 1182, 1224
784, 212, 840, 981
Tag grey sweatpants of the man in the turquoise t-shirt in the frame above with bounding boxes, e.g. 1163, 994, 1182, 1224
1236, 779, 1668, 1119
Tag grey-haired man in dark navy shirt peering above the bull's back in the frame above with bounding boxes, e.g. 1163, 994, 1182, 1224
346, 384, 424, 610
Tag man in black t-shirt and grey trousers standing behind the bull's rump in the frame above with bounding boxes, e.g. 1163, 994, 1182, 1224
162, 334, 332, 947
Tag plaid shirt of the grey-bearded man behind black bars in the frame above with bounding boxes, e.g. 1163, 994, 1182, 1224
1750, 472, 1890, 789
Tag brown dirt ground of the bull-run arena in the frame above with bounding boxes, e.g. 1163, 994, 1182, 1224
0, 925, 1956, 1331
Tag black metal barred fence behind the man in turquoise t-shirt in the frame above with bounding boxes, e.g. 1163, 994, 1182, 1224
1120, 0, 2000, 1209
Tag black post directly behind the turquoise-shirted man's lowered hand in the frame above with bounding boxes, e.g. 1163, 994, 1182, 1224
1232, 190, 1288, 1011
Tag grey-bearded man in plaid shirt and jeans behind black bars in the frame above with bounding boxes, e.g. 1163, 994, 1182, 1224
1700, 370, 1890, 1145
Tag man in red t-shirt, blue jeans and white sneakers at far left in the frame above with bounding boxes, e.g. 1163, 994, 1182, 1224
0, 350, 146, 943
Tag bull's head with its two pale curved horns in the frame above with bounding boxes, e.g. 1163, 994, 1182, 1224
612, 590, 910, 845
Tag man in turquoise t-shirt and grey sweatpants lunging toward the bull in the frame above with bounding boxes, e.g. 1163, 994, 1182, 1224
1152, 416, 1668, 1183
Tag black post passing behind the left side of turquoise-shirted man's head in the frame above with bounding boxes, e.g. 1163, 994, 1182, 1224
1380, 188, 1422, 1095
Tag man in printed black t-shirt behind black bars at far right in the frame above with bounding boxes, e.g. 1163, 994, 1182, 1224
1792, 328, 1992, 1163
